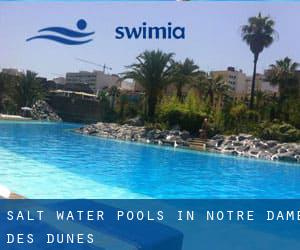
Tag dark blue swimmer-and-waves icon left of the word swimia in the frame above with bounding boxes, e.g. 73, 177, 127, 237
26, 19, 95, 45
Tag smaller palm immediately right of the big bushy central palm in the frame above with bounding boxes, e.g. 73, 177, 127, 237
173, 58, 200, 101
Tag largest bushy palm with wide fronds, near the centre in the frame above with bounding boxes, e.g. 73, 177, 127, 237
123, 50, 174, 119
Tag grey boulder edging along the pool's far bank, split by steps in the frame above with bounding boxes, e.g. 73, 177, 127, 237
76, 122, 300, 162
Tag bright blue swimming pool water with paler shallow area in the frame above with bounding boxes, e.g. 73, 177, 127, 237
0, 122, 300, 198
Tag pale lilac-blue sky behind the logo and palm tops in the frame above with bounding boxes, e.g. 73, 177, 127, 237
0, 2, 300, 79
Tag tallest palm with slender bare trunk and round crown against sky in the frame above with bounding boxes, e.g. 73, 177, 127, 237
242, 13, 275, 109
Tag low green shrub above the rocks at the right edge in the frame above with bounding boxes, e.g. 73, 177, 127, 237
258, 123, 300, 142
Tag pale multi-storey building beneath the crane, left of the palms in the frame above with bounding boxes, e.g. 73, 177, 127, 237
66, 70, 121, 92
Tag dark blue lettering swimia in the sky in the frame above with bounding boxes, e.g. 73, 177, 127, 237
115, 22, 186, 39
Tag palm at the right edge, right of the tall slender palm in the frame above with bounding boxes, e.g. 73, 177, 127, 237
267, 57, 299, 101
